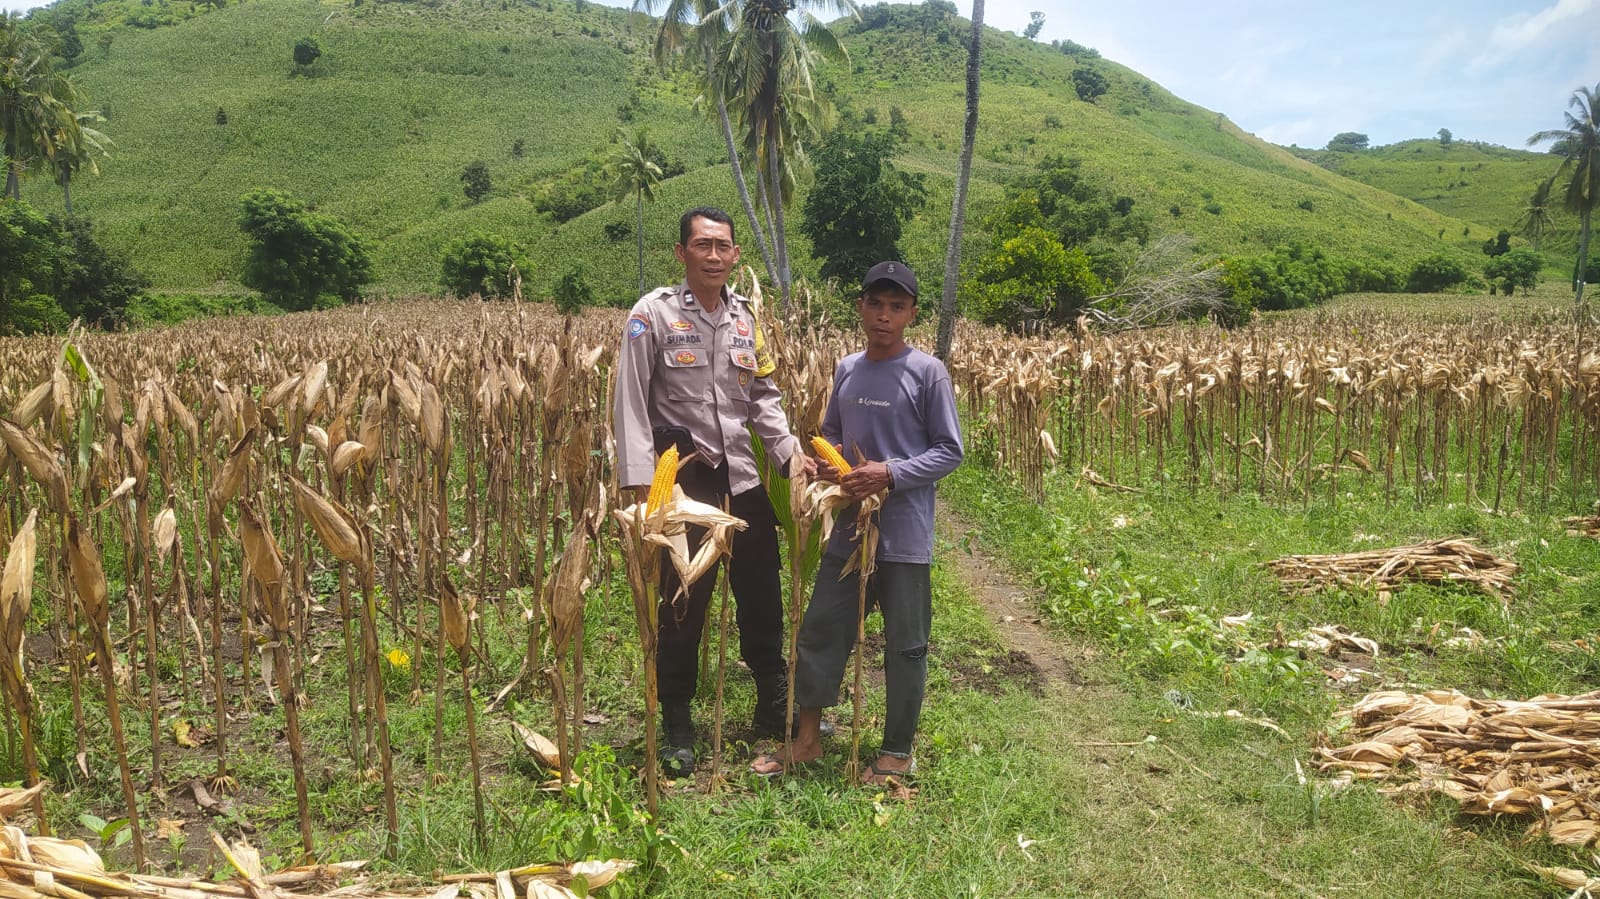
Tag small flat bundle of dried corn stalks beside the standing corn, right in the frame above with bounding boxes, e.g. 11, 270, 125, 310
1267, 539, 1517, 598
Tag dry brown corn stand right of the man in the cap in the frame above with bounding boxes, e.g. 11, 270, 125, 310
950, 314, 1600, 512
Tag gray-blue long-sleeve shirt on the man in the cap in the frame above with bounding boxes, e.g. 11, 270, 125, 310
822, 347, 963, 565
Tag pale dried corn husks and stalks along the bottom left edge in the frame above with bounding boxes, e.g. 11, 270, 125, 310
0, 787, 634, 899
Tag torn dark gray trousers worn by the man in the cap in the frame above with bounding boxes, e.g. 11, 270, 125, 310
795, 555, 933, 758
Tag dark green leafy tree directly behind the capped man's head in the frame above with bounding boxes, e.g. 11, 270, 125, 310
800, 128, 928, 282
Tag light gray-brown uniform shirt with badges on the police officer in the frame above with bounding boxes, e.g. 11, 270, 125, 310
611, 285, 798, 493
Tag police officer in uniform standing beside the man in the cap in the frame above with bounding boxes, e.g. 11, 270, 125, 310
613, 208, 814, 773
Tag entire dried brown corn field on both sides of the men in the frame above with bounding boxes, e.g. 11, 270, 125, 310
0, 302, 1600, 865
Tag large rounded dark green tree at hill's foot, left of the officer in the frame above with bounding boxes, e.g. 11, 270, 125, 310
238, 189, 373, 310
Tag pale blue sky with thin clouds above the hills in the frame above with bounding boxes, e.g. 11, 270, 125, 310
0, 0, 1600, 147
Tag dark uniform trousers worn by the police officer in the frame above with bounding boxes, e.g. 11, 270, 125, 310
656, 462, 787, 705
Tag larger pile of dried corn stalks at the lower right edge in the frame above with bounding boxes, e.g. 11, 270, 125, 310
1318, 689, 1600, 846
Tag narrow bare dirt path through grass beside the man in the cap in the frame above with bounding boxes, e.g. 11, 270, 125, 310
938, 504, 1096, 694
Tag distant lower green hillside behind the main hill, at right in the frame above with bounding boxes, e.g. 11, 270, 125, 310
1299, 139, 1571, 243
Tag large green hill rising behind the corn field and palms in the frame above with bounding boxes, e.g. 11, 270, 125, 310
15, 0, 1497, 302
